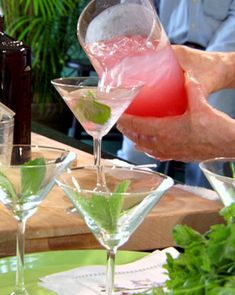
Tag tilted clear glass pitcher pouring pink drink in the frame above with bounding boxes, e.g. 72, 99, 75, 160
78, 0, 187, 117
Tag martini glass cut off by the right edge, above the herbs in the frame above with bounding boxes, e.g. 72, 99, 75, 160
199, 158, 235, 206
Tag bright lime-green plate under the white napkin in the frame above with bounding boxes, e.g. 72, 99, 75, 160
0, 250, 146, 295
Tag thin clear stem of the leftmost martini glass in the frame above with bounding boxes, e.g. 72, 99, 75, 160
13, 219, 28, 295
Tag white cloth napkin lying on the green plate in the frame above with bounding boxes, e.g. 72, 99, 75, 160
39, 247, 179, 295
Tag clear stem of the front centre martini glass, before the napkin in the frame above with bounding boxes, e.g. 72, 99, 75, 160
105, 249, 117, 295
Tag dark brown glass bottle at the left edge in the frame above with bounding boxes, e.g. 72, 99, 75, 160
0, 16, 32, 144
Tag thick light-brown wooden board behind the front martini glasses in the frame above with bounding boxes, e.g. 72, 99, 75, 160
0, 134, 222, 256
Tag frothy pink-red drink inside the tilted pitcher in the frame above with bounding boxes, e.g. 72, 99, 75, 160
86, 35, 187, 117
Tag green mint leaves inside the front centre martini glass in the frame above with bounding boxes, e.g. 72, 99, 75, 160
67, 181, 129, 233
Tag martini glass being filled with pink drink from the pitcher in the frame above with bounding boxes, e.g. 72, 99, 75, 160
52, 76, 143, 191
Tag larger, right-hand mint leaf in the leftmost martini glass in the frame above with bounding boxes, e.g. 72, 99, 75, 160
21, 158, 46, 197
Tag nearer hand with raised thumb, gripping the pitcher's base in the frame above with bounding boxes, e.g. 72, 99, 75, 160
118, 74, 235, 162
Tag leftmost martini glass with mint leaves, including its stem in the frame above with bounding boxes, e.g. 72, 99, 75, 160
0, 145, 75, 295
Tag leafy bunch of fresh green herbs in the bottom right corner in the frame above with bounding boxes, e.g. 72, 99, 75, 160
136, 204, 235, 295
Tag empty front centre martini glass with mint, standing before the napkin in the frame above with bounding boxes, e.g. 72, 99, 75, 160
56, 166, 173, 295
